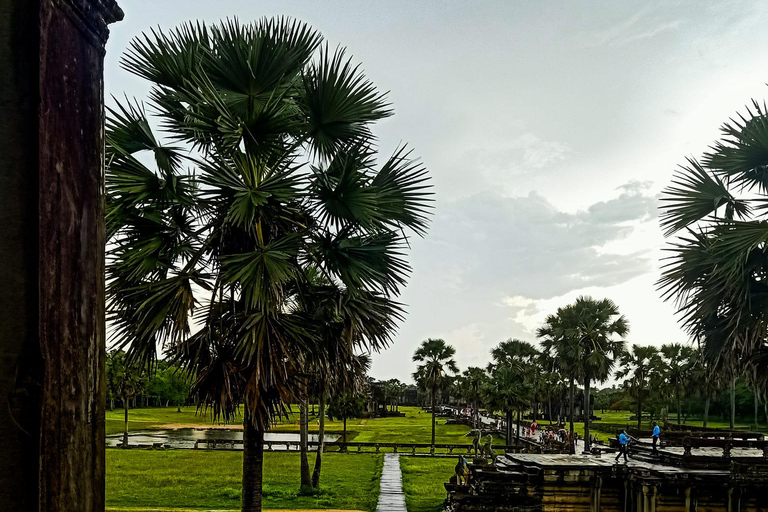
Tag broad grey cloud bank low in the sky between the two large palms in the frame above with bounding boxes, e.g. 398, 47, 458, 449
414, 182, 656, 302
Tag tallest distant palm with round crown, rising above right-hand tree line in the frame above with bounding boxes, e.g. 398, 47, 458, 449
540, 297, 629, 452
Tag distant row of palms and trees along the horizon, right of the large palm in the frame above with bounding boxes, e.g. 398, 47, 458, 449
413, 297, 768, 449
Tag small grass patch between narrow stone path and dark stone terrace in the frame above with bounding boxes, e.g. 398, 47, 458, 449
400, 457, 457, 512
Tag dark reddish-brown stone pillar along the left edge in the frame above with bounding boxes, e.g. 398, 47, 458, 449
0, 0, 123, 512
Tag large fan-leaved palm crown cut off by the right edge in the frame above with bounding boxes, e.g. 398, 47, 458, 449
659, 101, 768, 396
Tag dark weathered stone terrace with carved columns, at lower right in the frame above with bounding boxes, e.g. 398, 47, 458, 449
446, 454, 768, 512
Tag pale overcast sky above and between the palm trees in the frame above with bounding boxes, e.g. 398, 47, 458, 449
105, 0, 768, 381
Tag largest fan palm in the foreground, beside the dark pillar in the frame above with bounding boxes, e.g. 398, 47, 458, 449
106, 19, 431, 511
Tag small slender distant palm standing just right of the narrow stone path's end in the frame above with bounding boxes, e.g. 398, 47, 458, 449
413, 338, 459, 453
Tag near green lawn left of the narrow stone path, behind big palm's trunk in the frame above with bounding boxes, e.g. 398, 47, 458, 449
106, 449, 382, 511
